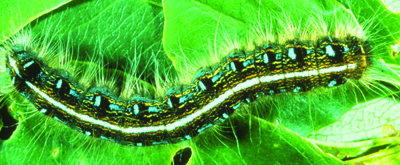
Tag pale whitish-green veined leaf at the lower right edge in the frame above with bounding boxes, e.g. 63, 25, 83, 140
309, 98, 400, 142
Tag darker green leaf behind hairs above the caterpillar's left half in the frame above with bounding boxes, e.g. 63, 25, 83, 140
32, 0, 170, 82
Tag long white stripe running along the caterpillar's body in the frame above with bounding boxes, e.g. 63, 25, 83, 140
25, 64, 357, 134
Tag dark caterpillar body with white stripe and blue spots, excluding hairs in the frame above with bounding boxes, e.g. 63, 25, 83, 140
6, 36, 370, 146
